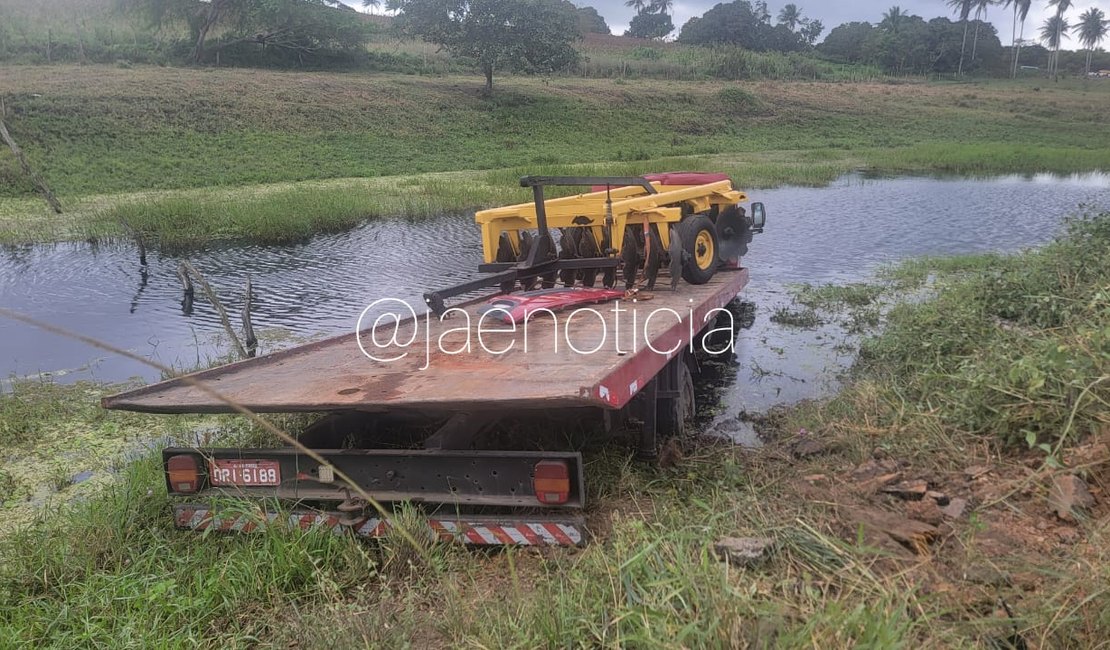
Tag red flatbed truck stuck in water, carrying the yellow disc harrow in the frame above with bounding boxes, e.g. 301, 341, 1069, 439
103, 174, 765, 546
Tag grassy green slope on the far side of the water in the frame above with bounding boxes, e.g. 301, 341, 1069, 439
0, 65, 1110, 244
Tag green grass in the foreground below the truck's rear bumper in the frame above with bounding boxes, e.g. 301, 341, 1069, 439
0, 439, 936, 648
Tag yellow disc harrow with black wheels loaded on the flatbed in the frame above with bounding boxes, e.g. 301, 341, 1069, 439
424, 172, 766, 314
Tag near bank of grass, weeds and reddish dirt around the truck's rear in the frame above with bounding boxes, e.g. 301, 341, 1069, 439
0, 214, 1110, 648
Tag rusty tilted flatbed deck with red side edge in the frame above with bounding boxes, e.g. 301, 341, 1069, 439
103, 268, 748, 413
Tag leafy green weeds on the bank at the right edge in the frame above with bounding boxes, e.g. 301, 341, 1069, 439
861, 212, 1110, 449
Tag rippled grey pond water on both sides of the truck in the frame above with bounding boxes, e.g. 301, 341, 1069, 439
0, 174, 1110, 428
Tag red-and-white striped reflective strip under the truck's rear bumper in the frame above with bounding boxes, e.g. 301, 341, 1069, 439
173, 504, 586, 546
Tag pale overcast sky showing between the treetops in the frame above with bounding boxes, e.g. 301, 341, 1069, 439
344, 0, 1110, 49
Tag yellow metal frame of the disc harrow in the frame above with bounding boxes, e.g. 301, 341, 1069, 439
474, 181, 748, 263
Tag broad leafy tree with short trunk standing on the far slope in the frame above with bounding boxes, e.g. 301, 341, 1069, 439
390, 0, 581, 94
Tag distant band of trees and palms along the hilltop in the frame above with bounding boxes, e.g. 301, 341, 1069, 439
0, 0, 1110, 85
